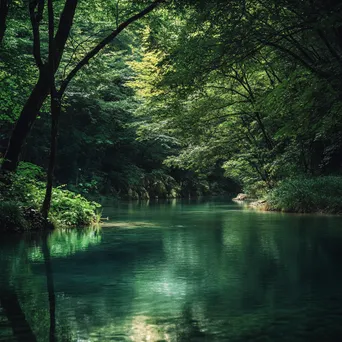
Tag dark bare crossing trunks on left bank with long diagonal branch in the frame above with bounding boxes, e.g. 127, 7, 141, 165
2, 0, 163, 217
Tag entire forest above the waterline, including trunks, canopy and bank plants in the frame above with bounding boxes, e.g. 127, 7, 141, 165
0, 0, 342, 231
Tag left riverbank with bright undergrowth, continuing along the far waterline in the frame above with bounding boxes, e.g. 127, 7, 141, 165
0, 162, 232, 232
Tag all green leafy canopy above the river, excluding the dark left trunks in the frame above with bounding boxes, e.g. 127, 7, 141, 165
0, 0, 342, 212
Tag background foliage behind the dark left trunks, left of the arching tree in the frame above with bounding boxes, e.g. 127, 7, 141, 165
0, 0, 238, 206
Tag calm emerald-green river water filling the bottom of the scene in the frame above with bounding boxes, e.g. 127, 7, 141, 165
0, 200, 342, 342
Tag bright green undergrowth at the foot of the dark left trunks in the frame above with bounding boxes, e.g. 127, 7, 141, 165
0, 162, 100, 231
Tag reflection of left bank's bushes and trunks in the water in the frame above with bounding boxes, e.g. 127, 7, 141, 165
0, 229, 100, 342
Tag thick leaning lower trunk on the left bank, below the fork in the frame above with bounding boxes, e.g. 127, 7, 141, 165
2, 71, 50, 172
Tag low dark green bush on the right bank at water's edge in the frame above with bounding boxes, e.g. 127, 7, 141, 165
267, 176, 342, 214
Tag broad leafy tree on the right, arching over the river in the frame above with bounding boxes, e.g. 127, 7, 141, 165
127, 0, 342, 191
